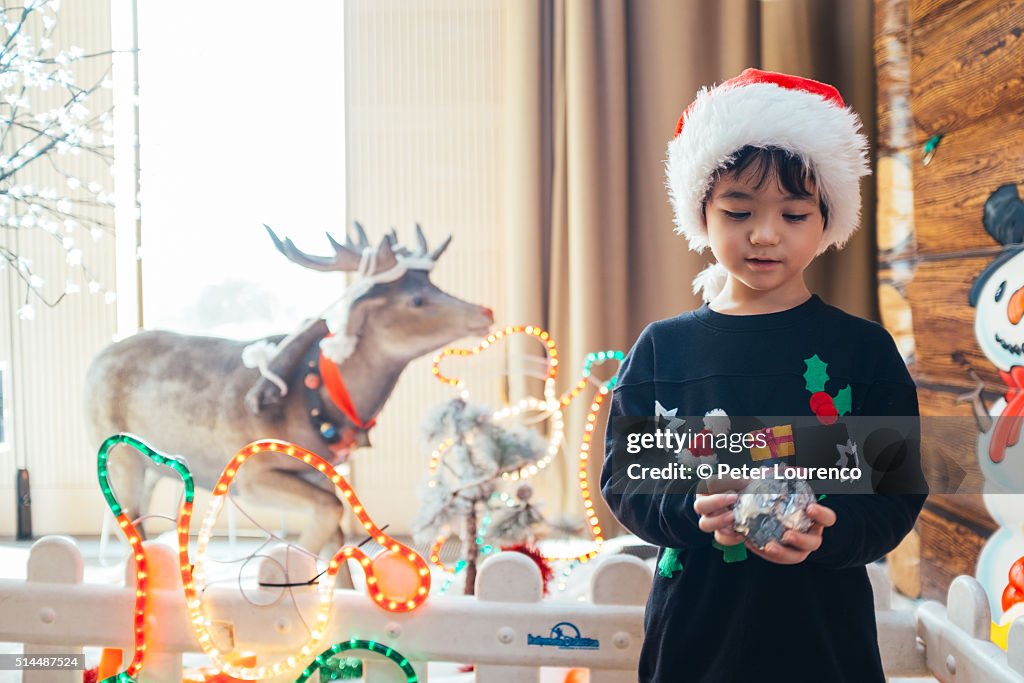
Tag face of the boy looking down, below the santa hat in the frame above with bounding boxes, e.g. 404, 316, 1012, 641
705, 168, 824, 296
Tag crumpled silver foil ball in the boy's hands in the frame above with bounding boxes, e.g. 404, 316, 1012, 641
733, 479, 815, 550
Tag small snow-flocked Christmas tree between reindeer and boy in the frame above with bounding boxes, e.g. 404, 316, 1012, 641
413, 398, 547, 595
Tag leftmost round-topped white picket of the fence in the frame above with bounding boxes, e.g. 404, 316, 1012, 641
22, 536, 84, 683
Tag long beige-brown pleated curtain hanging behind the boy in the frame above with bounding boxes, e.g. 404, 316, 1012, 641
502, 0, 878, 527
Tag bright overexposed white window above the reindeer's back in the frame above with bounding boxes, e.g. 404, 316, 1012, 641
131, 0, 345, 339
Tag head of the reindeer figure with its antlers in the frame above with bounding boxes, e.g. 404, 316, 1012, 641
264, 222, 494, 360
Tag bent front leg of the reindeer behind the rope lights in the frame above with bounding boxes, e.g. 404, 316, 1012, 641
234, 467, 352, 588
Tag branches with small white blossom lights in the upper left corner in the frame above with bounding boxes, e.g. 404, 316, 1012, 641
0, 0, 114, 321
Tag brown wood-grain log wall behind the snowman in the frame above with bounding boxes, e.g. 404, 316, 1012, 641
876, 0, 1024, 599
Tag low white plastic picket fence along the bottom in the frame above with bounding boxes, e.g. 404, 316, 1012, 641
0, 537, 1024, 683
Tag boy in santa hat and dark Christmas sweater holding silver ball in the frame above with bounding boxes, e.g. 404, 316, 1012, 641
601, 69, 927, 683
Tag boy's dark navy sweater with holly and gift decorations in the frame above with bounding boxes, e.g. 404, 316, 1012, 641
601, 296, 927, 683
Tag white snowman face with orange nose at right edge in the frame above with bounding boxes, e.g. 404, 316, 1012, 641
974, 251, 1024, 372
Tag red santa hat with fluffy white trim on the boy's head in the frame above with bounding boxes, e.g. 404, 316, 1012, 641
666, 69, 870, 301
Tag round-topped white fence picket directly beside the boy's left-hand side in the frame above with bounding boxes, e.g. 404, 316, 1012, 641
590, 555, 653, 683
